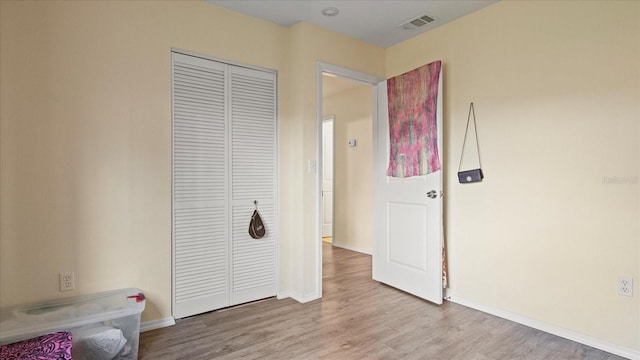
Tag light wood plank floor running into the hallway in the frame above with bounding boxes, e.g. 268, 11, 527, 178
139, 243, 622, 360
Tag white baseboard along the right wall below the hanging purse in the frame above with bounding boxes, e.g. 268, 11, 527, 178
445, 292, 640, 360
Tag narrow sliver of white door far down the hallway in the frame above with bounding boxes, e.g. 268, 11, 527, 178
322, 118, 333, 237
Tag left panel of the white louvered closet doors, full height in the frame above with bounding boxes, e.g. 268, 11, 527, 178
173, 53, 229, 318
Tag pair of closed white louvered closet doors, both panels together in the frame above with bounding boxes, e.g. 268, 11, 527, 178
172, 53, 278, 318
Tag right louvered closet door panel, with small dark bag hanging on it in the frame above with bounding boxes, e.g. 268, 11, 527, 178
230, 67, 278, 305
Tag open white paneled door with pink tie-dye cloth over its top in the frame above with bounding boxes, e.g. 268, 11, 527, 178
373, 76, 443, 304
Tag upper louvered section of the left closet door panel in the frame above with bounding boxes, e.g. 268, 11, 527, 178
173, 54, 227, 206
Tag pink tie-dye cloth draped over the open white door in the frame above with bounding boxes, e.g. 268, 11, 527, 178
387, 61, 442, 177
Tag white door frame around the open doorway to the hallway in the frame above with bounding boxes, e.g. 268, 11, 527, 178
315, 61, 385, 298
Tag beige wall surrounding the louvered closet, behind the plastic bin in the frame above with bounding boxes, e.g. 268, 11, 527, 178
0, 1, 384, 321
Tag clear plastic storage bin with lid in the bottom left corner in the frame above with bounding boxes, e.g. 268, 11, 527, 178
0, 288, 145, 360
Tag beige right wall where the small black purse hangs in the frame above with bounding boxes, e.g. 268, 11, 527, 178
387, 1, 640, 350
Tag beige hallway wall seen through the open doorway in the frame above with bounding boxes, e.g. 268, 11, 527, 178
322, 80, 373, 254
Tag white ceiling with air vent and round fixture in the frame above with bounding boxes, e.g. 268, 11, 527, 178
204, 0, 498, 48
